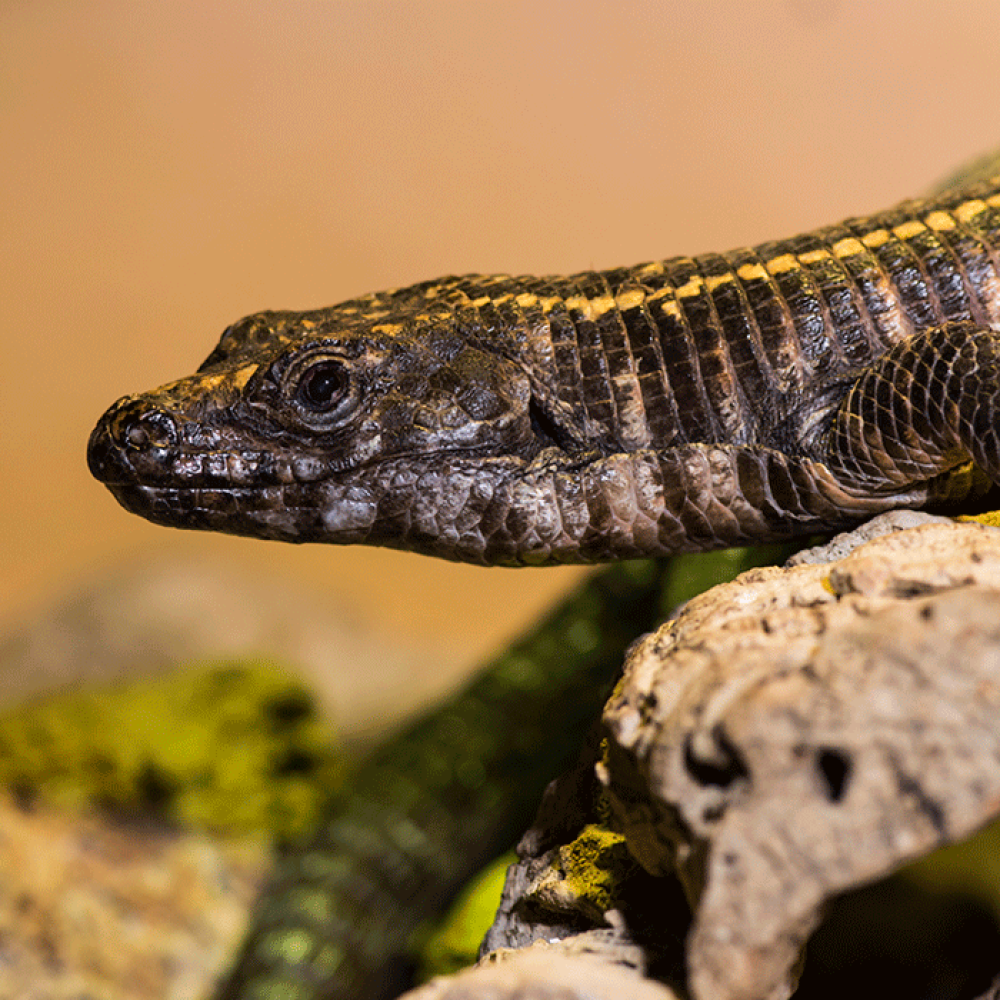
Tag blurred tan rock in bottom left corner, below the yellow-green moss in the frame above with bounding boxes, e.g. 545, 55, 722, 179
0, 797, 271, 1000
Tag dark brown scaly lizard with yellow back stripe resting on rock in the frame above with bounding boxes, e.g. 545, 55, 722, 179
88, 160, 1000, 997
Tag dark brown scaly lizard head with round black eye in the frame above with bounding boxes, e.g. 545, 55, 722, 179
88, 293, 596, 562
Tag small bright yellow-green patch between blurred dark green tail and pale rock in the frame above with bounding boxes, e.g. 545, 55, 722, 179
420, 851, 517, 981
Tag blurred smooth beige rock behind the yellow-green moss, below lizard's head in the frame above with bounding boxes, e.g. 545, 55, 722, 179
0, 556, 450, 740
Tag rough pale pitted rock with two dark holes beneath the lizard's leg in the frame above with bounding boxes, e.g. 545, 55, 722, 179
603, 525, 1000, 1000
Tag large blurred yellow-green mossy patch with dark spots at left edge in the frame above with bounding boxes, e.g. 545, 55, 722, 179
0, 661, 341, 835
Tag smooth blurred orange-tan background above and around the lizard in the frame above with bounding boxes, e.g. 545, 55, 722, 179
0, 0, 1000, 682
